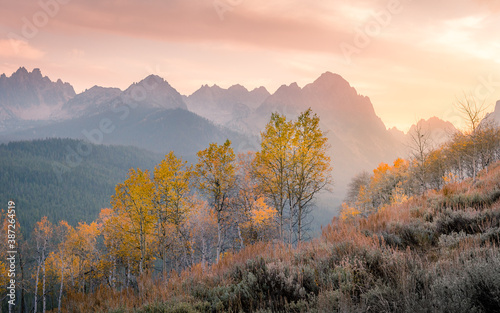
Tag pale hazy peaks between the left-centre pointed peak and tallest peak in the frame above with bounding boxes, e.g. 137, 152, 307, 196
185, 85, 270, 131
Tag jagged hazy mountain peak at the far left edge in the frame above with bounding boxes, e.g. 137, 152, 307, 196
0, 67, 75, 122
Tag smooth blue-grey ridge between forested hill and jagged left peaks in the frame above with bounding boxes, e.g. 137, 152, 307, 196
0, 106, 257, 161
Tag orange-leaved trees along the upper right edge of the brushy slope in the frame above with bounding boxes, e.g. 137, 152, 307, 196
341, 96, 500, 218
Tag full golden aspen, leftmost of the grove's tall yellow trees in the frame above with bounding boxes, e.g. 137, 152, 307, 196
111, 169, 156, 274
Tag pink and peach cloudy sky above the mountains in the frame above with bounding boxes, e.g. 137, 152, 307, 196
0, 0, 500, 130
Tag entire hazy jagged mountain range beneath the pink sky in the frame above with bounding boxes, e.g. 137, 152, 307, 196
0, 68, 500, 200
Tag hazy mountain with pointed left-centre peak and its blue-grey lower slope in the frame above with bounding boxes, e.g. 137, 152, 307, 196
0, 68, 257, 160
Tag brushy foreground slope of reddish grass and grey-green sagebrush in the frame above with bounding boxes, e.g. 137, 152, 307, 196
68, 163, 500, 312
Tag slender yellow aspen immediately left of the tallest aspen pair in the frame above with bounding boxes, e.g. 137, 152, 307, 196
195, 140, 236, 262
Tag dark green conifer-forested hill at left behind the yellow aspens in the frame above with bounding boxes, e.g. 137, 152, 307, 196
0, 139, 161, 237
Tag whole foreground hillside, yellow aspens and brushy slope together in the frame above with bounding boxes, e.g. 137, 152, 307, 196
0, 101, 500, 313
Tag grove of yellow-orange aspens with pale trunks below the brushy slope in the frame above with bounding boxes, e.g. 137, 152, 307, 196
0, 109, 332, 312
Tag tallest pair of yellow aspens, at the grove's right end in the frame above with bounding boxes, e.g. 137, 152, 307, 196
254, 109, 332, 243
